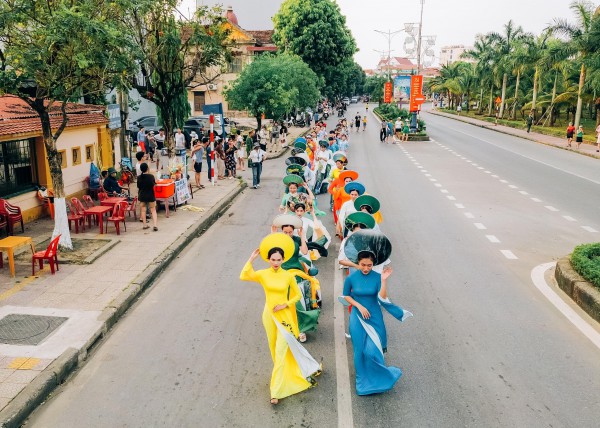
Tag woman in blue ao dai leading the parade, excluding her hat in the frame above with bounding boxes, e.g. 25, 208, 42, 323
343, 251, 412, 395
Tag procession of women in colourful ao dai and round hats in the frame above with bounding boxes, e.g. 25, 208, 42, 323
240, 111, 412, 404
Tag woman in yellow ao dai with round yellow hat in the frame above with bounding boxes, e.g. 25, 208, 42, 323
240, 233, 321, 404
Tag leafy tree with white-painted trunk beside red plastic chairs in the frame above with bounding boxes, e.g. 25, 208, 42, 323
0, 0, 136, 248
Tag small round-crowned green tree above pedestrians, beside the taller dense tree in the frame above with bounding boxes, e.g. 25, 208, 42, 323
225, 54, 320, 128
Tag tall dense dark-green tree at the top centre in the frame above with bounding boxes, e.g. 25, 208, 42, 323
273, 0, 357, 95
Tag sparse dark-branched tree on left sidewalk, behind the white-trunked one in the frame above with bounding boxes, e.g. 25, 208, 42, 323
129, 0, 228, 155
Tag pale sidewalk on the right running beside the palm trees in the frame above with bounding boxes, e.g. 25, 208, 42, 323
424, 110, 600, 159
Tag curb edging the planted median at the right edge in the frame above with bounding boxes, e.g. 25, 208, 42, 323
554, 256, 600, 322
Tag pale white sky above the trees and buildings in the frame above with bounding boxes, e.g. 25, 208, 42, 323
182, 0, 574, 69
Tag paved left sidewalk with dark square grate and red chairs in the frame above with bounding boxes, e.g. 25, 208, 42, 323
0, 127, 308, 427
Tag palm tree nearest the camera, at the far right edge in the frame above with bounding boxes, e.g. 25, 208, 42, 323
548, 0, 598, 128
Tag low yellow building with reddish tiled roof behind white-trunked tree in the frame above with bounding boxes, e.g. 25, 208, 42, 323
0, 95, 114, 222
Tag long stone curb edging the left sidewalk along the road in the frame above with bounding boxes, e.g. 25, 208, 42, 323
0, 182, 247, 428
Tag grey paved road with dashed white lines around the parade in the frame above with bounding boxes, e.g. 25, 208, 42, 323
29, 105, 600, 427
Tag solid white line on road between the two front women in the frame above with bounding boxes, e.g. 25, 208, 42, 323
333, 269, 354, 427
